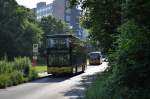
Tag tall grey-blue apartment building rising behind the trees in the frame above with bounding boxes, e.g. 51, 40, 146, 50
33, 0, 84, 38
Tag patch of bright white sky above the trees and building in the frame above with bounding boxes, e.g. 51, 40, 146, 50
16, 0, 54, 9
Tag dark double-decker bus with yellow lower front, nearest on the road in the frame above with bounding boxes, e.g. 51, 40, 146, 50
47, 34, 87, 75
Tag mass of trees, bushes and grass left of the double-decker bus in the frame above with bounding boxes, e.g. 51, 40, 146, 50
0, 0, 73, 88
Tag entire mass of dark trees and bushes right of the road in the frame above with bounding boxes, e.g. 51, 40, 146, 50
71, 0, 150, 99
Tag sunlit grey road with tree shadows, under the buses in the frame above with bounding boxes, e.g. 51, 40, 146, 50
0, 62, 107, 99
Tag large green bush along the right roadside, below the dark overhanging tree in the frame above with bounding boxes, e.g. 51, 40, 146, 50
85, 20, 150, 99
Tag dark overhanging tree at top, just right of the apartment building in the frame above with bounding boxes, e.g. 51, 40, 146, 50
70, 0, 121, 53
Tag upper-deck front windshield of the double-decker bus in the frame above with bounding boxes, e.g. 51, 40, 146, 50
47, 38, 69, 49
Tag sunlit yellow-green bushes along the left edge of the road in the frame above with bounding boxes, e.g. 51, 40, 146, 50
0, 57, 38, 88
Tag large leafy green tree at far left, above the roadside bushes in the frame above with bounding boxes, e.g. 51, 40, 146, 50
0, 0, 43, 59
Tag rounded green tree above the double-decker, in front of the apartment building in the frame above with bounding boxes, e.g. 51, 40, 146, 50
40, 16, 73, 52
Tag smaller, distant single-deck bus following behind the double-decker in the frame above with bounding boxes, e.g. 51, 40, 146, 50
88, 52, 102, 65
